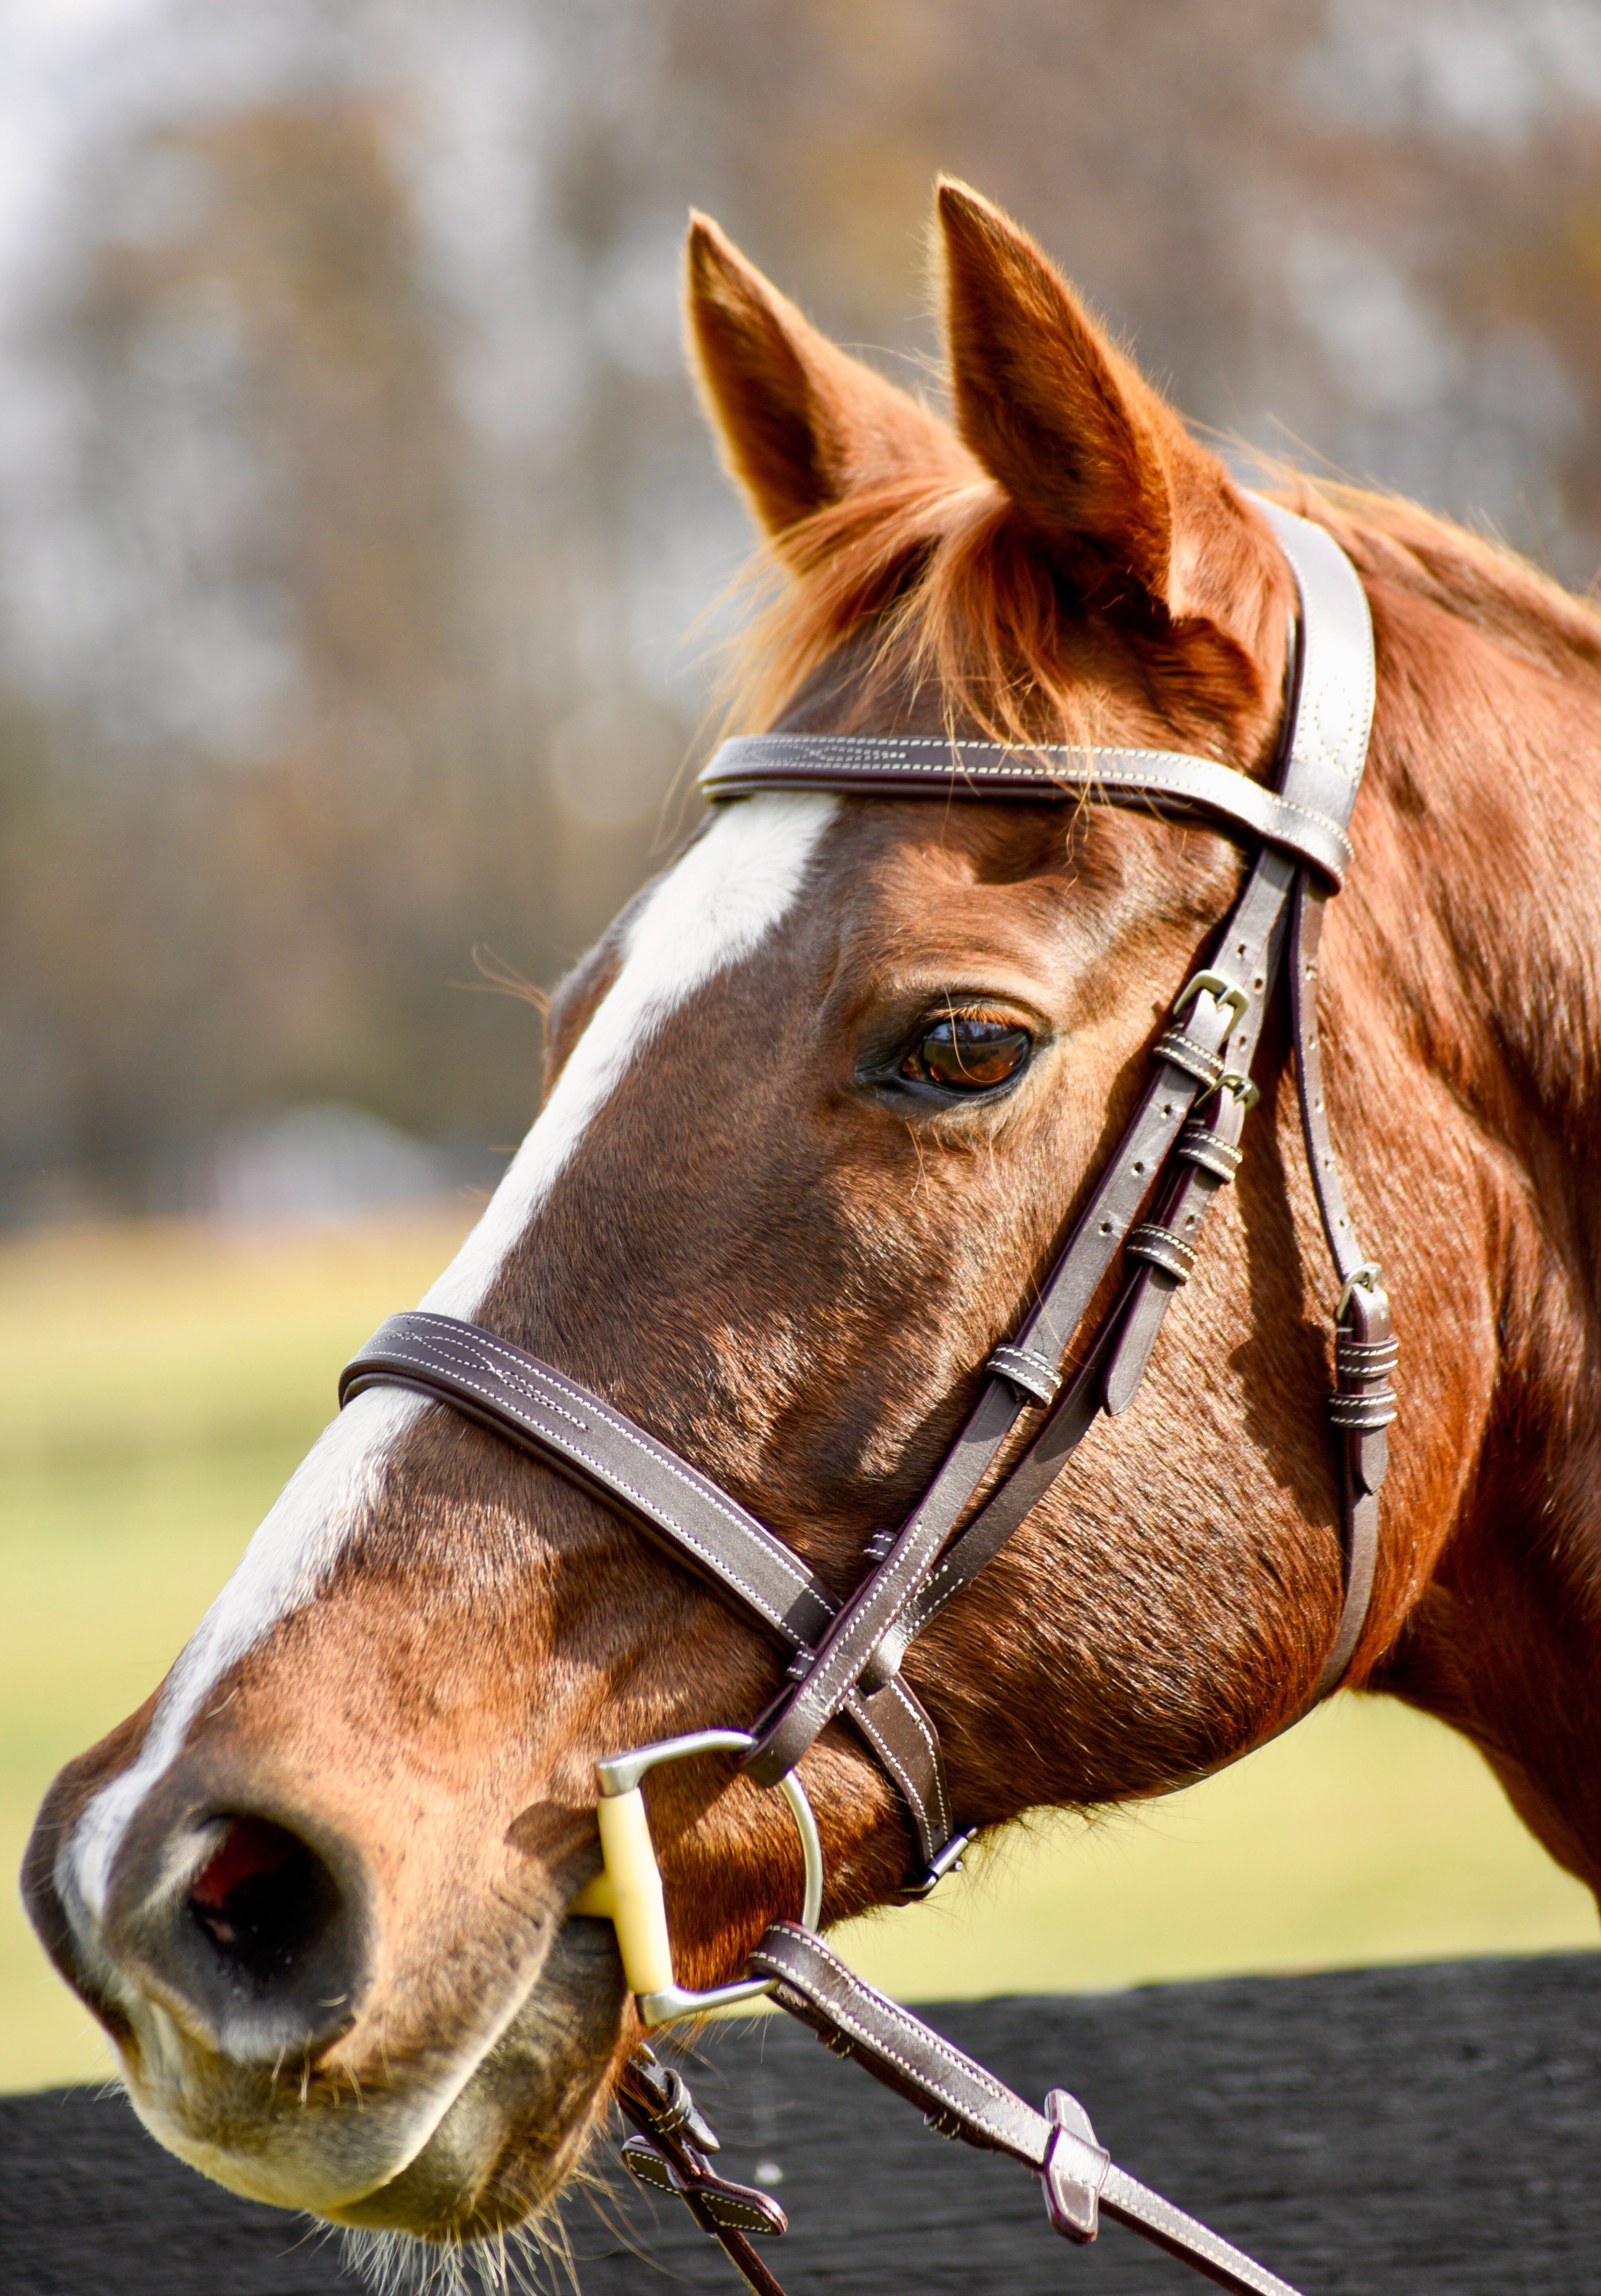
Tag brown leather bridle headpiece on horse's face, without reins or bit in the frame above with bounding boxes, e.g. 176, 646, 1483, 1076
340, 503, 1392, 1871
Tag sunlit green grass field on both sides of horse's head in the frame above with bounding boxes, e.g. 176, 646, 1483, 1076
0, 1208, 1601, 2090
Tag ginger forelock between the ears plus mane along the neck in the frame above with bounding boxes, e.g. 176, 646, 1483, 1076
728, 468, 1601, 741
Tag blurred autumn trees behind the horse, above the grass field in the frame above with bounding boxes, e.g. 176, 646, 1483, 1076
0, 0, 1601, 1212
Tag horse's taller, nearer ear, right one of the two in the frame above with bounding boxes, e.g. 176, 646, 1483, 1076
940, 179, 1243, 615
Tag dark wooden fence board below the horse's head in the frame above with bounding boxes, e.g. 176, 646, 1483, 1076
0, 1954, 1601, 2296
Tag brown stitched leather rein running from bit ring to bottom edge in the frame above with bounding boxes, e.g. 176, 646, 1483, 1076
749, 1922, 1296, 2296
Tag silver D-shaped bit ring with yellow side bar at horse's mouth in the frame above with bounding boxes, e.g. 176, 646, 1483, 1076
567, 1729, 822, 2027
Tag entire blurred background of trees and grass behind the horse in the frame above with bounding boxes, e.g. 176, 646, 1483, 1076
0, 0, 1601, 2085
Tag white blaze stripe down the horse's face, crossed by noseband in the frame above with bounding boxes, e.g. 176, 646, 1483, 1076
60, 794, 838, 1919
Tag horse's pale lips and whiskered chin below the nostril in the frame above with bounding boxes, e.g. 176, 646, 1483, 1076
111, 1919, 625, 2243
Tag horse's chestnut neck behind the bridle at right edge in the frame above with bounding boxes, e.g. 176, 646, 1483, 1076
1330, 560, 1601, 1887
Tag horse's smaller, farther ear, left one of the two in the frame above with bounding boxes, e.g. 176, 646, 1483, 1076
687, 216, 976, 555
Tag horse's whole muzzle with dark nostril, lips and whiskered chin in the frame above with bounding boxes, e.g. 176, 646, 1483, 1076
25, 1752, 625, 2239
